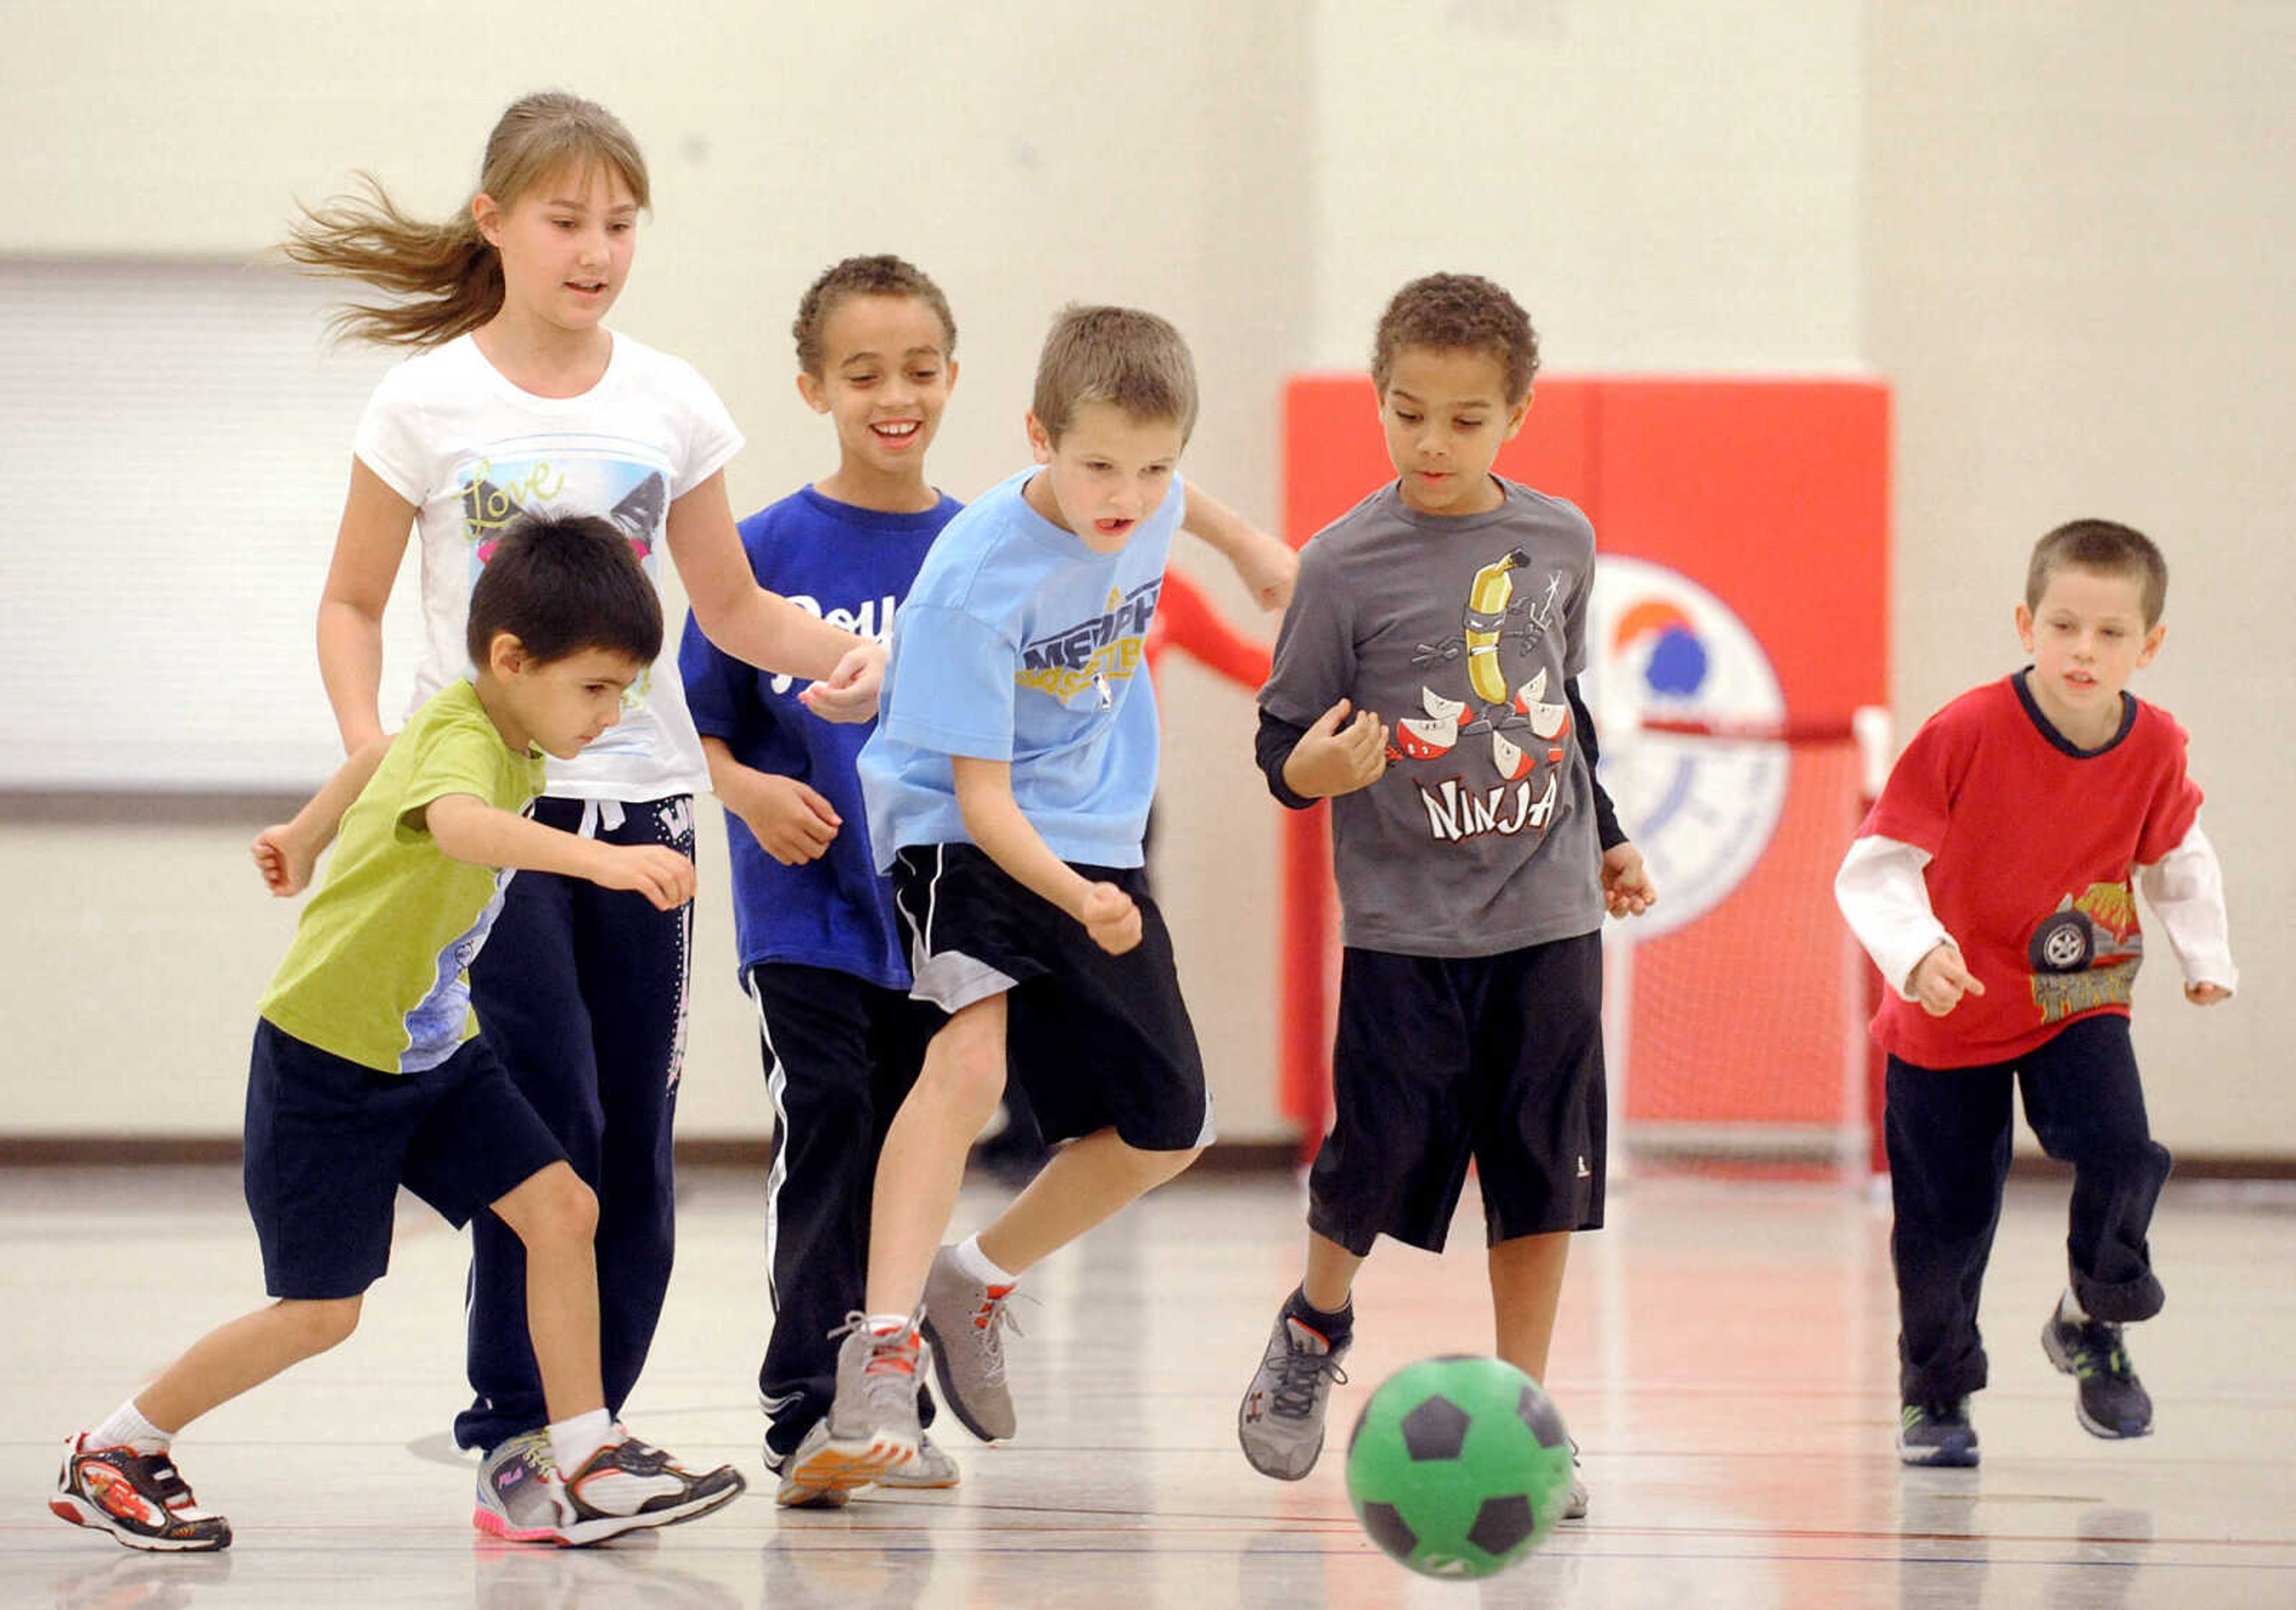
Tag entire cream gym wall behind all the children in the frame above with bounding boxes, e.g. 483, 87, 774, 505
0, 0, 2296, 1155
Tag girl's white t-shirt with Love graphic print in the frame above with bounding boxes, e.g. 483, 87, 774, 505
352, 335, 741, 802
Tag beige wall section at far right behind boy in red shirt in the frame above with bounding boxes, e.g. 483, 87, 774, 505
1864, 0, 2296, 1157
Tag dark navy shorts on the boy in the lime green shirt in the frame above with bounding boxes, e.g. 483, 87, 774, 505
243, 1020, 565, 1302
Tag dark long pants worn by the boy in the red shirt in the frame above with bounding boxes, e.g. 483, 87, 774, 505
1885, 1013, 2170, 1403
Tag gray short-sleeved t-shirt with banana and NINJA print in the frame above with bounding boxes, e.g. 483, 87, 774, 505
1260, 480, 1602, 955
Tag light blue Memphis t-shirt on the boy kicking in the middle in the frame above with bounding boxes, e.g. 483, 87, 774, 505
859, 466, 1187, 868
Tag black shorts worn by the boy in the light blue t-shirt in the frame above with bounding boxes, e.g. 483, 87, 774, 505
893, 843, 1213, 1151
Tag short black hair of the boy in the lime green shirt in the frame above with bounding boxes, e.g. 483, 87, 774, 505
464, 515, 661, 666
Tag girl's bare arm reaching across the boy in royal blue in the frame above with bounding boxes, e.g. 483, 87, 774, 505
666, 471, 884, 721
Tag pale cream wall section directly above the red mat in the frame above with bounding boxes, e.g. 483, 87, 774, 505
1309, 0, 1864, 369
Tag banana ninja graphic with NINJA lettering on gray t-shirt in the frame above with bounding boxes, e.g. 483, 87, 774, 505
1387, 549, 1571, 841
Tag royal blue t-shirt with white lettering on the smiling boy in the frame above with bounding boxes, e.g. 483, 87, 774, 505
677, 487, 962, 990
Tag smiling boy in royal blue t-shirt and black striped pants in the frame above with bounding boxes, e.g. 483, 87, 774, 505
677, 257, 962, 1507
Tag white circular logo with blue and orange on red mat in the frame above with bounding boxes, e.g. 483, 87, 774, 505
1586, 554, 1791, 939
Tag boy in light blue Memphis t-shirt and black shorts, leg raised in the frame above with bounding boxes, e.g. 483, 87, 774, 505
790, 308, 1297, 1488
